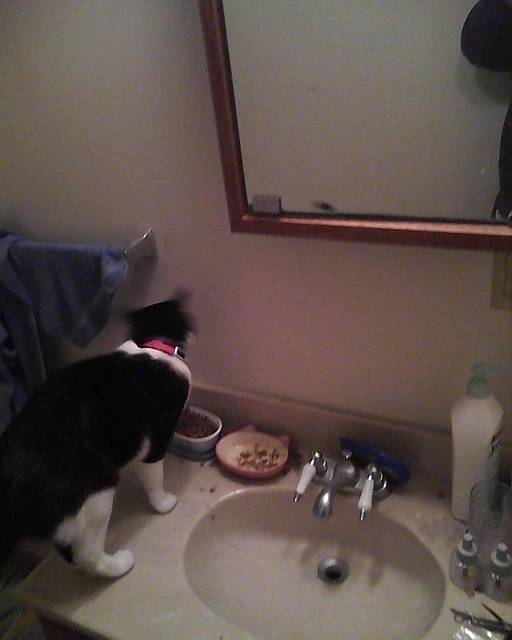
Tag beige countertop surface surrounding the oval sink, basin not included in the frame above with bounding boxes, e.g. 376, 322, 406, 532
16, 455, 512, 640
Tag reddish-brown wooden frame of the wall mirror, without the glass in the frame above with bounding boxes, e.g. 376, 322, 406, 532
199, 0, 512, 251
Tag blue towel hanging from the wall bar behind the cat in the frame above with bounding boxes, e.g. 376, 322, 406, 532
0, 231, 128, 433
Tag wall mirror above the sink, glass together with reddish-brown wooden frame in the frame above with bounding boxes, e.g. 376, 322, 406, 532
199, 0, 512, 251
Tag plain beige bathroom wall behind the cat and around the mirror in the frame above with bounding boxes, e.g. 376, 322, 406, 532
0, 0, 512, 439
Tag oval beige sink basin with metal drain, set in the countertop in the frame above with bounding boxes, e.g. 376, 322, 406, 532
184, 487, 446, 640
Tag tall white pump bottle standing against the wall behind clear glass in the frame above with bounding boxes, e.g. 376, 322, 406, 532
451, 362, 503, 522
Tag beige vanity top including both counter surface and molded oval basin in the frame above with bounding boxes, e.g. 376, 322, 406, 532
17, 456, 484, 640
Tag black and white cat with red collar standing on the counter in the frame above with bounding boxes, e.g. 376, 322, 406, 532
0, 295, 193, 578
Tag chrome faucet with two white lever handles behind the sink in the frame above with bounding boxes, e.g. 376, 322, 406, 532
294, 449, 390, 520
